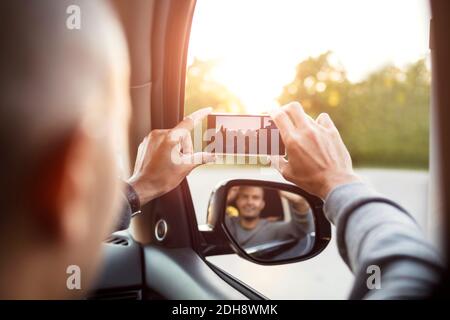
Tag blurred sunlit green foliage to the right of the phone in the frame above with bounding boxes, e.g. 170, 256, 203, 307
279, 52, 430, 168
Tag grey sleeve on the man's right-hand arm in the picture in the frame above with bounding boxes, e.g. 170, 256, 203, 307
324, 183, 442, 299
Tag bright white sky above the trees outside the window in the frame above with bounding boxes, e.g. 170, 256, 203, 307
188, 0, 430, 113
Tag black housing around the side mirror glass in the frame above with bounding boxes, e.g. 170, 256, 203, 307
202, 179, 331, 265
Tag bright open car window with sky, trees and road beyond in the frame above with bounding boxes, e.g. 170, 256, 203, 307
185, 0, 431, 299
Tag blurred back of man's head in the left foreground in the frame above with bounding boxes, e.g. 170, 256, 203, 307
0, 0, 128, 296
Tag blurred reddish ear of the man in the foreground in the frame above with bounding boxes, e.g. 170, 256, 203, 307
30, 130, 93, 242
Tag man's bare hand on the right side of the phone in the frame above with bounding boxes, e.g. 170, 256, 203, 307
271, 102, 359, 199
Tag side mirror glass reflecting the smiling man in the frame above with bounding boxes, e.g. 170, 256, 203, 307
225, 185, 315, 260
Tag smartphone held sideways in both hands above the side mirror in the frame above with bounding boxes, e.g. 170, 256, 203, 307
205, 113, 286, 155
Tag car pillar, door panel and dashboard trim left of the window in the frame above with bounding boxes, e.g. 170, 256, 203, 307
90, 0, 263, 299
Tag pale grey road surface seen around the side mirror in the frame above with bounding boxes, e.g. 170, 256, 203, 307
188, 166, 428, 299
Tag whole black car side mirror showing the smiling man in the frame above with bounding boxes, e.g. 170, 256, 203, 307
204, 179, 331, 265
